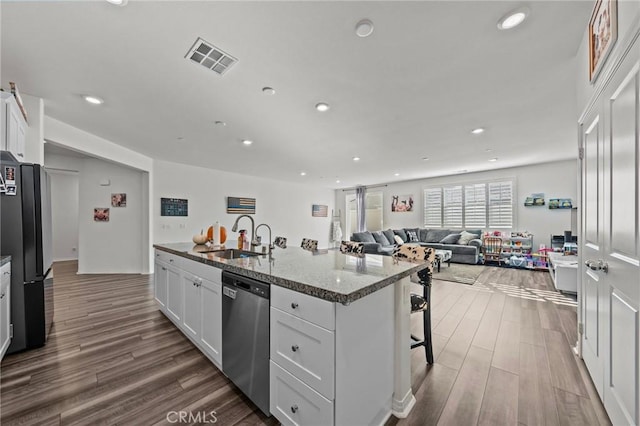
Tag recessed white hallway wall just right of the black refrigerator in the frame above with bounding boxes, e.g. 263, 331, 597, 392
49, 170, 80, 262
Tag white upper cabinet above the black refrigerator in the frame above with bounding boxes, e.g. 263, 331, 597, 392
0, 92, 27, 161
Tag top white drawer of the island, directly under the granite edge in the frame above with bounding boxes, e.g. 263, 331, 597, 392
271, 285, 336, 330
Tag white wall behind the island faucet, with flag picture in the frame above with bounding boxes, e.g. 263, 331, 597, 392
152, 161, 334, 251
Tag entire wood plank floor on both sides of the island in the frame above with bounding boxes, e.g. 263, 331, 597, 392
0, 262, 609, 426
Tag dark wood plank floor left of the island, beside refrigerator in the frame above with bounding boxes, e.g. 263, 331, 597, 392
0, 262, 277, 426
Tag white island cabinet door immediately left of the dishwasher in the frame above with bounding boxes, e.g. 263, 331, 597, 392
200, 279, 222, 366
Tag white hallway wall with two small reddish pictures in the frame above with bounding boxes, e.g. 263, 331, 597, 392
45, 155, 149, 274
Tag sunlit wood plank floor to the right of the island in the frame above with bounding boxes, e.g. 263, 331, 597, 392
387, 267, 610, 426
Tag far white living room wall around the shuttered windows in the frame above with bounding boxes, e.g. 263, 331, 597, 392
336, 160, 577, 251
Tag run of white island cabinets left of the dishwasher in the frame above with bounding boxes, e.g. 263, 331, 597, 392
154, 250, 222, 368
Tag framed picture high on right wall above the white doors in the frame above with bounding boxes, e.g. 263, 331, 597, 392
589, 0, 618, 82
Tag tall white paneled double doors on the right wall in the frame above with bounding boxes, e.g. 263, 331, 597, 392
581, 40, 640, 425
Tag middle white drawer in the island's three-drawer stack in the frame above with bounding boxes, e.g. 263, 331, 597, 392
270, 307, 335, 399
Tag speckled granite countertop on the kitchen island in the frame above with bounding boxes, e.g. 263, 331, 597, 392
154, 243, 426, 304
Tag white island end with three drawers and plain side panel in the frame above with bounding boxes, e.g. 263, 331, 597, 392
269, 285, 396, 425
